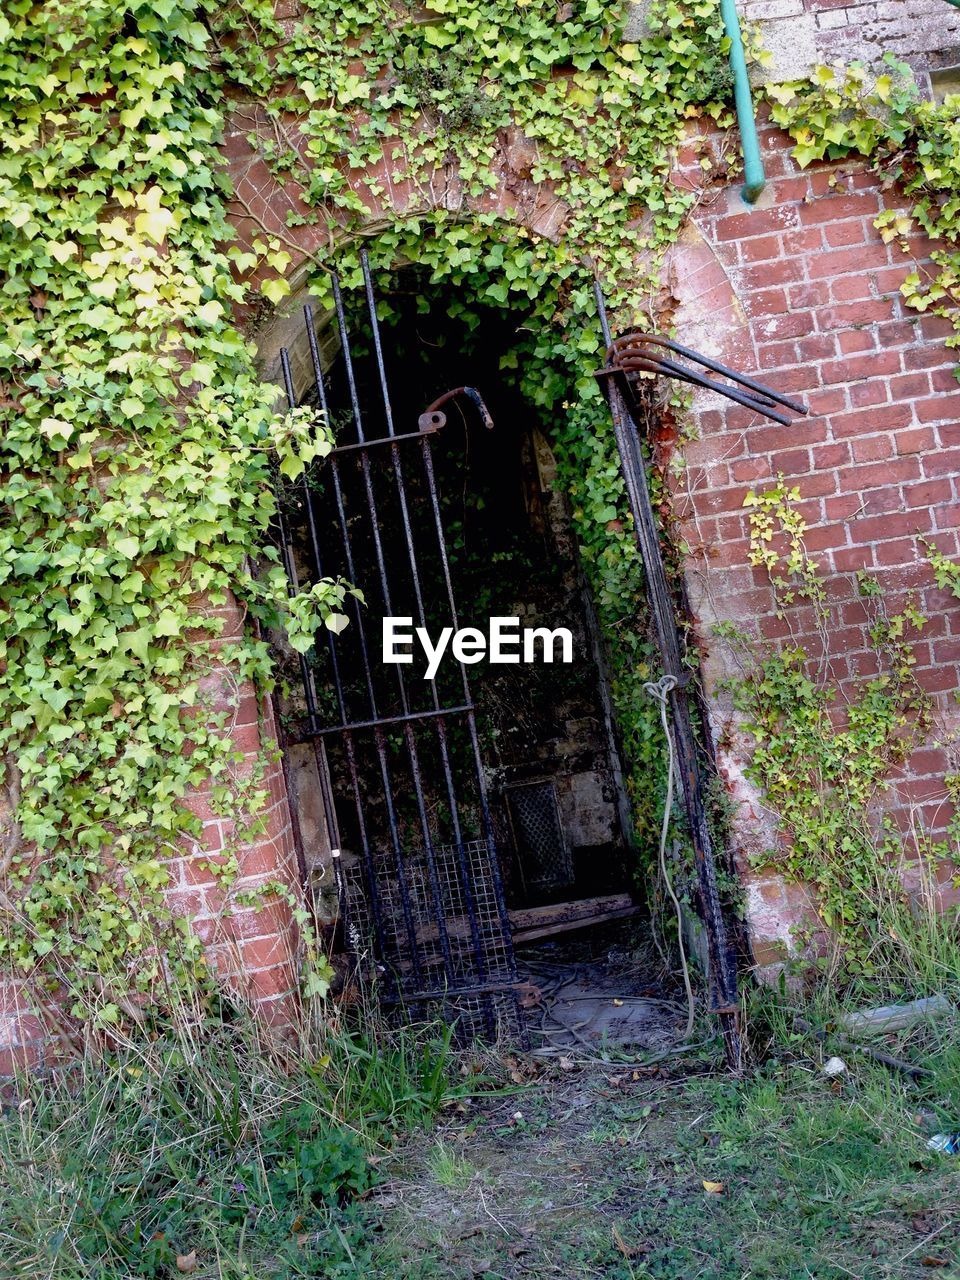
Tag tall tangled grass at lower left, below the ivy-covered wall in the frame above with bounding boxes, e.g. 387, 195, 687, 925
0, 1019, 465, 1280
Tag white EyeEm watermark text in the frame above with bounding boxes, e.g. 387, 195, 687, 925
383, 617, 573, 680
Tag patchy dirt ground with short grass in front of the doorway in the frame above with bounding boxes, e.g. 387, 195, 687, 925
363, 1061, 960, 1280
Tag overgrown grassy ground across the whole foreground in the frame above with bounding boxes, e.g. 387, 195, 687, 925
0, 880, 960, 1280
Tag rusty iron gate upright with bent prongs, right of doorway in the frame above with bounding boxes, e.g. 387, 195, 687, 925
594, 280, 806, 1071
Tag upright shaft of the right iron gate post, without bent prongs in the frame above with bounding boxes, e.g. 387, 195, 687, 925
594, 283, 741, 1070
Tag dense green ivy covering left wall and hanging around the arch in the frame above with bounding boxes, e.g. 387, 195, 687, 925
0, 0, 724, 1018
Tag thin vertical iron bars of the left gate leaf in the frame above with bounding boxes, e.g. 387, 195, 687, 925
280, 251, 516, 1034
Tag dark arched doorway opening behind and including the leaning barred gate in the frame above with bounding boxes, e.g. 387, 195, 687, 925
282, 257, 655, 1032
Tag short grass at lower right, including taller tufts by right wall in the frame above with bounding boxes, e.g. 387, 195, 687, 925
360, 902, 960, 1280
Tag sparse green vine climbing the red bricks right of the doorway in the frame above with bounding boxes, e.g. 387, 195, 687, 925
716, 480, 955, 973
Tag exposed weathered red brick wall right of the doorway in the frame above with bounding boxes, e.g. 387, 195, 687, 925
671, 115, 960, 963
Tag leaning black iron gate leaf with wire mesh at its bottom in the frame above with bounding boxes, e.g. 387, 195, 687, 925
280, 253, 518, 1037
